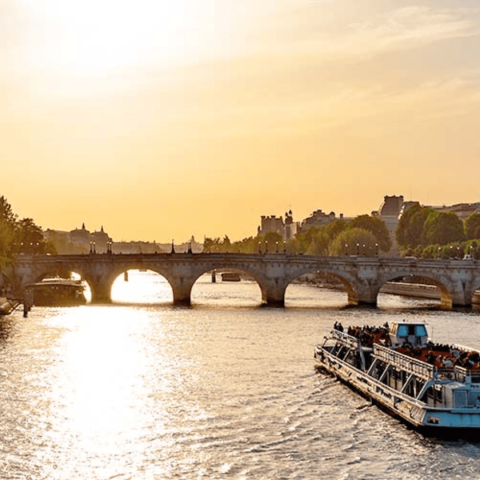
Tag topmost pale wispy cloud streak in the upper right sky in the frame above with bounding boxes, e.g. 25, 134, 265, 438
258, 2, 480, 60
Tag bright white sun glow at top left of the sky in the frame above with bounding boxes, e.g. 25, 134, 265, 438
20, 0, 211, 77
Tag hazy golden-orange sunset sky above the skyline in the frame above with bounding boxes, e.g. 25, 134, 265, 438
0, 0, 480, 243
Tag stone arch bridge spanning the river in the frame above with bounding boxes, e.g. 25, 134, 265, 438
4, 253, 480, 307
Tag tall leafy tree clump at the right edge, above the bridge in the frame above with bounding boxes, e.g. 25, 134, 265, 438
396, 205, 480, 259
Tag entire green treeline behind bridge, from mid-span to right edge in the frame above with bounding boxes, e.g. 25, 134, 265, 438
204, 205, 480, 259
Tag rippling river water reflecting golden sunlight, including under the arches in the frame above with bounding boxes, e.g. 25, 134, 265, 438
0, 272, 480, 480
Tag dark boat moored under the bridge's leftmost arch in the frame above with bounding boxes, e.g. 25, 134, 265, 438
25, 278, 87, 307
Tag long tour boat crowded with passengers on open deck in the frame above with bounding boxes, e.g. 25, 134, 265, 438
314, 322, 480, 436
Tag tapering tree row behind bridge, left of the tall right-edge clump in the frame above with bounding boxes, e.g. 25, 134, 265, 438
203, 215, 392, 255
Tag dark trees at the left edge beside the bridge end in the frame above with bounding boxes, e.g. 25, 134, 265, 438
0, 196, 55, 271
